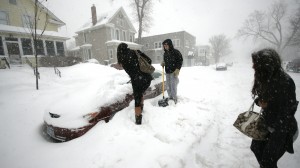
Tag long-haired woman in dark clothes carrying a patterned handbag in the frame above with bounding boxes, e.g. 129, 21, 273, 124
250, 48, 298, 168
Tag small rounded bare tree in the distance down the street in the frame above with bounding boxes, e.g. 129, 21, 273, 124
209, 34, 231, 63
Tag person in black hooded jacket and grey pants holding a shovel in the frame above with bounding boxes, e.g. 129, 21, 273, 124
161, 39, 183, 104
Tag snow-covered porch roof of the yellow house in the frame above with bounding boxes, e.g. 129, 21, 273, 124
0, 24, 69, 40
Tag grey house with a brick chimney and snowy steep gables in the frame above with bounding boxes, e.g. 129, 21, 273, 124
71, 5, 142, 65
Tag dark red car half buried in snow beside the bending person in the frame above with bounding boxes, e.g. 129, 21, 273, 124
42, 66, 162, 142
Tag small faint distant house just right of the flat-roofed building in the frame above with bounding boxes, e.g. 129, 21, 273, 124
195, 45, 215, 65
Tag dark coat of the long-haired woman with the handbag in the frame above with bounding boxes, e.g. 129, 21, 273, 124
256, 70, 298, 153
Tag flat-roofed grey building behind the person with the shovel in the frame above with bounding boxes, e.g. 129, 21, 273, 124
141, 31, 196, 66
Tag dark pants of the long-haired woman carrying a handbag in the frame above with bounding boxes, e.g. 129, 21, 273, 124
250, 131, 287, 168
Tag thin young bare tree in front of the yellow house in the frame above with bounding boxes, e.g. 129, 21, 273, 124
23, 0, 49, 90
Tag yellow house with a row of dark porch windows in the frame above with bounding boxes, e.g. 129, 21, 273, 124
0, 0, 68, 64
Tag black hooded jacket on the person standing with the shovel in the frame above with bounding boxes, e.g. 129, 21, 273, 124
163, 39, 183, 74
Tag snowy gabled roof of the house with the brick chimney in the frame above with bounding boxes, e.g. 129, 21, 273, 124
76, 7, 136, 33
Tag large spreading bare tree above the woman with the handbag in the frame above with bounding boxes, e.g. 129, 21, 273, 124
237, 1, 300, 53
